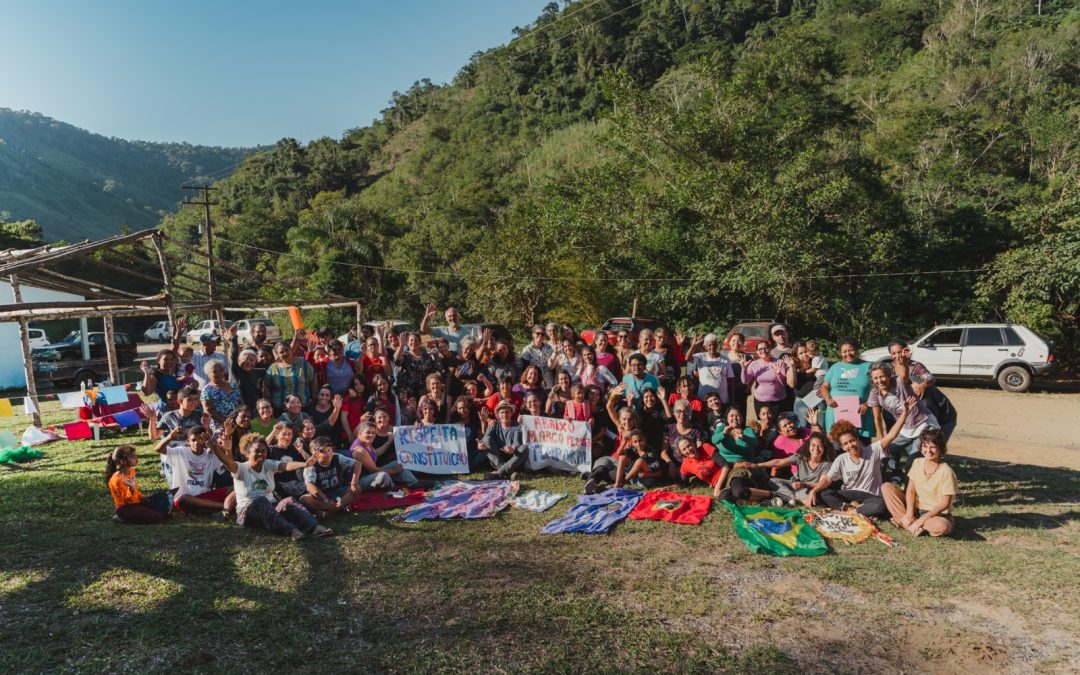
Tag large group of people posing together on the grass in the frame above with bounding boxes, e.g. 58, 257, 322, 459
106, 306, 957, 538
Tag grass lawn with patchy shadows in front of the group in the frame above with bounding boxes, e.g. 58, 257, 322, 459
0, 404, 1080, 673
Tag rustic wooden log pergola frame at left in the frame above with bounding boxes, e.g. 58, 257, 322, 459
0, 229, 363, 427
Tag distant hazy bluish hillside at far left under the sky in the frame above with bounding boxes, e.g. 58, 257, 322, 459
0, 108, 252, 241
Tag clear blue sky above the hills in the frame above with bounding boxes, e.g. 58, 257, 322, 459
0, 0, 548, 146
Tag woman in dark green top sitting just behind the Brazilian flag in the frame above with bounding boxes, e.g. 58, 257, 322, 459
713, 406, 770, 501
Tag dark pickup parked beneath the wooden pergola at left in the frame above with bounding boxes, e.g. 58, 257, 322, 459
30, 330, 138, 387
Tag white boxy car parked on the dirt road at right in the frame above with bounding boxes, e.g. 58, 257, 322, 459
862, 323, 1054, 392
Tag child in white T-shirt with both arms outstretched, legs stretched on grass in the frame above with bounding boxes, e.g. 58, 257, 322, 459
208, 433, 334, 541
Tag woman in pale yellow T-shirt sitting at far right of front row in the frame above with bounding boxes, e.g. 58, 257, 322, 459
881, 429, 957, 537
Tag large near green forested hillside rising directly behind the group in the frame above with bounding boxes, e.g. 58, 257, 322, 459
156, 0, 1080, 358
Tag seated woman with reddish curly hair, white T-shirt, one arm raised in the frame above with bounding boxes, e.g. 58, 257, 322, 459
821, 399, 916, 517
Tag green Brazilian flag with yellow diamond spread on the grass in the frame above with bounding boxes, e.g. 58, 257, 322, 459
721, 501, 828, 556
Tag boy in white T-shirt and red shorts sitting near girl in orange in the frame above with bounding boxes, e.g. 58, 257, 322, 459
154, 424, 232, 515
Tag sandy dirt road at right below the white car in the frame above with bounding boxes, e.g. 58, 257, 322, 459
942, 387, 1080, 470
